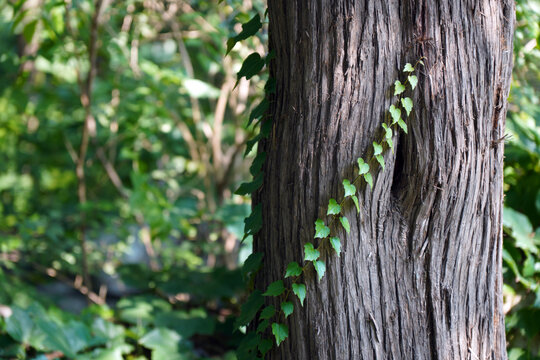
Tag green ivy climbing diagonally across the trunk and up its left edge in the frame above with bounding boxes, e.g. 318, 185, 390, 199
227, 9, 424, 359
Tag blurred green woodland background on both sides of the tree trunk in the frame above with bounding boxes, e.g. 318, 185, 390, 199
0, 0, 540, 360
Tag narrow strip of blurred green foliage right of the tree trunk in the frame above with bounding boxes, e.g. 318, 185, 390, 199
503, 0, 540, 360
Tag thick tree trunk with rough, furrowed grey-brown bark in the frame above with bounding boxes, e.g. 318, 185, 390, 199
254, 0, 514, 359
